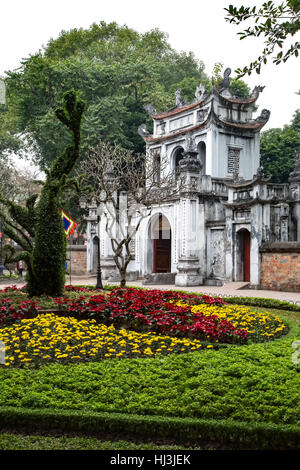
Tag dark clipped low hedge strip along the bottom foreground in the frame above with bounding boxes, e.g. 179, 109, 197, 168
0, 407, 300, 450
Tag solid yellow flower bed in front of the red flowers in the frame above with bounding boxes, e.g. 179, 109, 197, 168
0, 314, 213, 367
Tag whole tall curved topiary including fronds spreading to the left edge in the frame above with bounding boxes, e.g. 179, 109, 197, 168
0, 90, 85, 296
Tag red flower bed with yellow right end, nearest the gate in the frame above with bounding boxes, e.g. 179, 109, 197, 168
0, 287, 287, 344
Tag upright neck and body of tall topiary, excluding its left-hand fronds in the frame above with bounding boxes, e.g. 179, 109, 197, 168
27, 91, 85, 296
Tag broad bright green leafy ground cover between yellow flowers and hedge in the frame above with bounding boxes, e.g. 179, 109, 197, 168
0, 326, 300, 429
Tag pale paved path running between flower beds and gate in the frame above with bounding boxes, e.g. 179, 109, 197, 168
0, 275, 300, 304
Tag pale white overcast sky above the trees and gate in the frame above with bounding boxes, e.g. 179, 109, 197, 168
0, 0, 300, 160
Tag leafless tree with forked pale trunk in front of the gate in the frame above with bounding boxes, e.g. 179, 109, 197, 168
78, 142, 184, 286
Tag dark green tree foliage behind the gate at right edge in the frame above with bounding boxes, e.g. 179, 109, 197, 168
260, 110, 300, 183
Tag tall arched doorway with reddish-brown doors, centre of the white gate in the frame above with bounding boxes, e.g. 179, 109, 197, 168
152, 214, 171, 273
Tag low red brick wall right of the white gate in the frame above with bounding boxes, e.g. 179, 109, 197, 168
260, 242, 300, 292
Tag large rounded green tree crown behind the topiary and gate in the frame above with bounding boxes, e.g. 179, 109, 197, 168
2, 22, 208, 168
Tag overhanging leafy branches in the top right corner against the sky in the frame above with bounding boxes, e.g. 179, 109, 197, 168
225, 0, 300, 77
